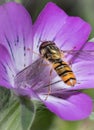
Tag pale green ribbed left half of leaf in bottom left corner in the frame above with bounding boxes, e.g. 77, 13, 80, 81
0, 97, 22, 130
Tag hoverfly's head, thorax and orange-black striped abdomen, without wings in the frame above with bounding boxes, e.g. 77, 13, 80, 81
39, 41, 76, 86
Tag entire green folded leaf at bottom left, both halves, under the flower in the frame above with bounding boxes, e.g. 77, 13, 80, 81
0, 90, 35, 130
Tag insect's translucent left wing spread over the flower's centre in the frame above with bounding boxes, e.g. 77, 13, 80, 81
15, 58, 50, 90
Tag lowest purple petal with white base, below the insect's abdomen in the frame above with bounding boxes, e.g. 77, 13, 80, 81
40, 92, 92, 120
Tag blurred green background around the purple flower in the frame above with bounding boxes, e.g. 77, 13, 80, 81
0, 0, 94, 130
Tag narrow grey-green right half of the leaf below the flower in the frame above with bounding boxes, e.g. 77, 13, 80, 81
20, 97, 35, 130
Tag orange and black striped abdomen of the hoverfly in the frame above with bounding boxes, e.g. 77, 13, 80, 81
53, 61, 76, 86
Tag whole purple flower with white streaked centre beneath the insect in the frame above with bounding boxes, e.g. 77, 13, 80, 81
0, 2, 94, 120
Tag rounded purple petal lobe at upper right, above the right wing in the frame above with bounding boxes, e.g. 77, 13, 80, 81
56, 17, 91, 51
